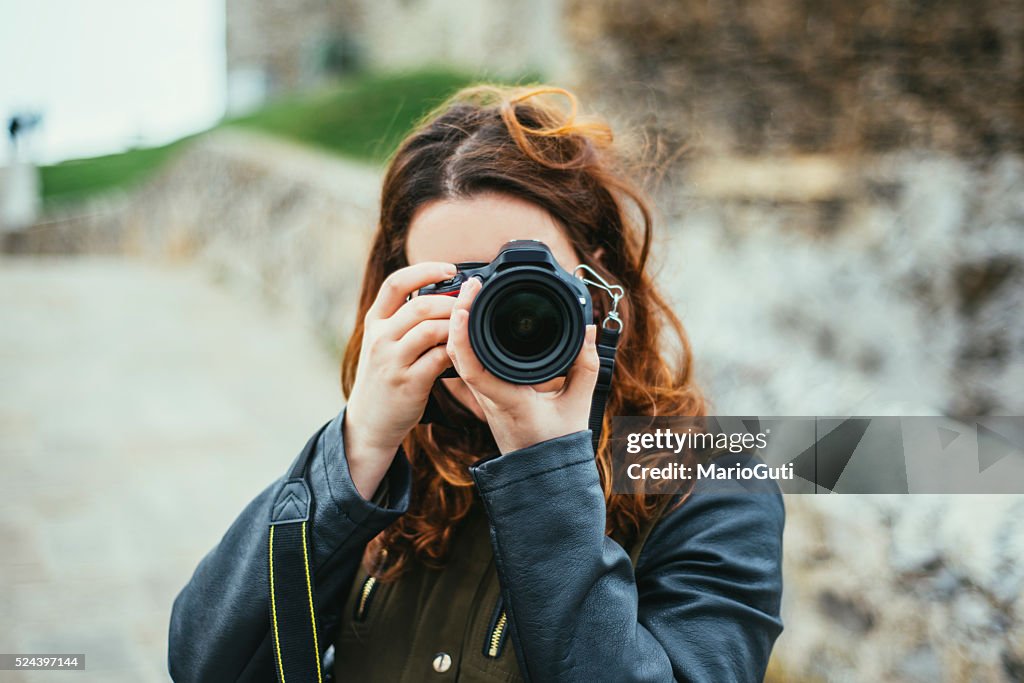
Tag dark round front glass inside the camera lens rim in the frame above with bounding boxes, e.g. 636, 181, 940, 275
490, 285, 565, 361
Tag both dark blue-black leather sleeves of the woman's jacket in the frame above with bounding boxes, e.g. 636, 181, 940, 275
168, 413, 784, 683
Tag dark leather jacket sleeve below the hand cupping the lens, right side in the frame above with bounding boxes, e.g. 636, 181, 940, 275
472, 430, 784, 683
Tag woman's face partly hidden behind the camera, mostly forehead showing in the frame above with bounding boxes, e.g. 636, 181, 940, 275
406, 189, 580, 420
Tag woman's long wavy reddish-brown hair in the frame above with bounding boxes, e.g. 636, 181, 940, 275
341, 85, 706, 581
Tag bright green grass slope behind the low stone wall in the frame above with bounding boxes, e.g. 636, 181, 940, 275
41, 70, 532, 207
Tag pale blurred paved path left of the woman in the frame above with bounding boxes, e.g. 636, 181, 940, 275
0, 257, 341, 683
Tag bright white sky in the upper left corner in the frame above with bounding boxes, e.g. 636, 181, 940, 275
0, 0, 225, 164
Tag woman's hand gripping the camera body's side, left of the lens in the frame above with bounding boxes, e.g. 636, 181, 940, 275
344, 261, 456, 501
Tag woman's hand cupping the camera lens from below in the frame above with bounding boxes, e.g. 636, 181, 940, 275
447, 278, 600, 454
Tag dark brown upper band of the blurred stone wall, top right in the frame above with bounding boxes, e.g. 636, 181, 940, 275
565, 0, 1024, 156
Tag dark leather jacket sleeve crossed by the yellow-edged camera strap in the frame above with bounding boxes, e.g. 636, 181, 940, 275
167, 411, 410, 683
